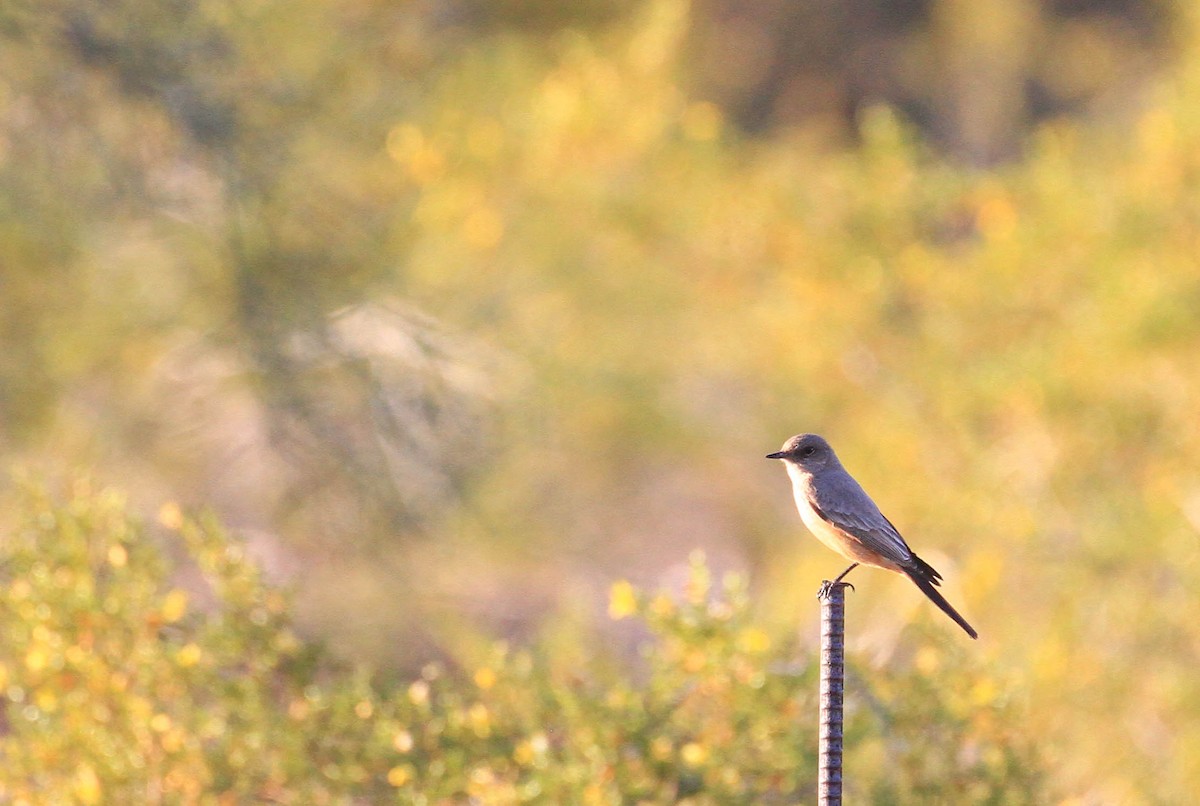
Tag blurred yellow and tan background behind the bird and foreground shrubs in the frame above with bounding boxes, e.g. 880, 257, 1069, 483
0, 0, 1200, 802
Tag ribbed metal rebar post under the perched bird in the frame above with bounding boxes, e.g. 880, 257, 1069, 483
817, 581, 850, 806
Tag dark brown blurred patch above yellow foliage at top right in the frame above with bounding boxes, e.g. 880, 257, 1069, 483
689, 0, 1186, 164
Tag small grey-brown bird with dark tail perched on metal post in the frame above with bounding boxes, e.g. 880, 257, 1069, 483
767, 434, 979, 638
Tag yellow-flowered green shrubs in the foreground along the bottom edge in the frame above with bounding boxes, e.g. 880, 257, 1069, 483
0, 483, 1044, 806
